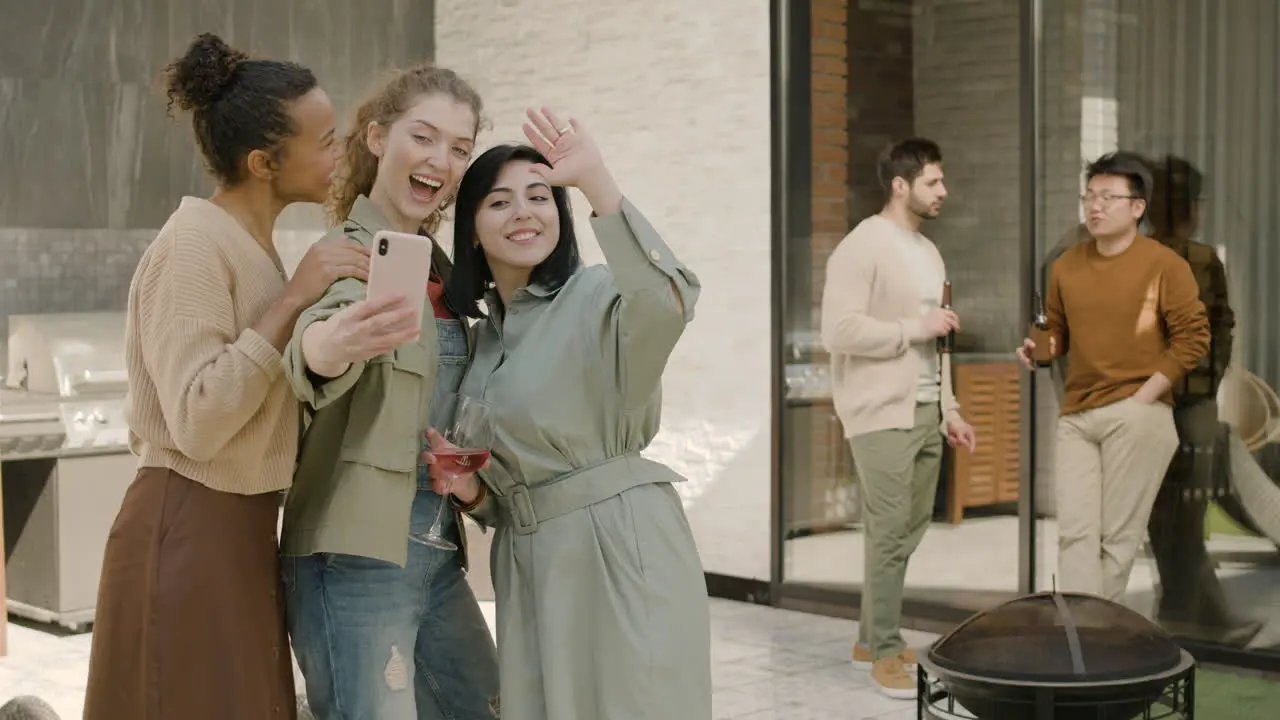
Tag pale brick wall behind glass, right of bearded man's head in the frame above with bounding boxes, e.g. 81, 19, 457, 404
913, 0, 1028, 352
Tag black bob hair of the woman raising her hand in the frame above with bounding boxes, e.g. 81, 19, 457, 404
444, 145, 582, 318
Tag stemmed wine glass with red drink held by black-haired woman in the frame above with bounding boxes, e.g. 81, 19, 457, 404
408, 392, 493, 550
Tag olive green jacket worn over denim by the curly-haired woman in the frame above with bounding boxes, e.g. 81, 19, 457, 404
280, 196, 471, 566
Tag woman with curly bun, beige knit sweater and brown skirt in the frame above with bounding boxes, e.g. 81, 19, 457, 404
84, 35, 367, 720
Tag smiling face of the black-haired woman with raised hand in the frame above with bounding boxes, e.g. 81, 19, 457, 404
476, 160, 561, 278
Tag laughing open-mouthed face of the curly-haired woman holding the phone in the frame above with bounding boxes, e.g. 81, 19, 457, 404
367, 92, 476, 232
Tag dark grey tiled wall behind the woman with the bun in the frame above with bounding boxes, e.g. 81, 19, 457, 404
0, 0, 434, 337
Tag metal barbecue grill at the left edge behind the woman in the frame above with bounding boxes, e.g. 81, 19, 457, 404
0, 313, 137, 629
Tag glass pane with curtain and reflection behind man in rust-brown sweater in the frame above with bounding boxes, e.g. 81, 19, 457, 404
1037, 0, 1280, 652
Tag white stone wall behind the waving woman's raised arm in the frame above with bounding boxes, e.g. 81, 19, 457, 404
435, 0, 772, 579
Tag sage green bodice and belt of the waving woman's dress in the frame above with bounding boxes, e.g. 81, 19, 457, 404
461, 199, 701, 527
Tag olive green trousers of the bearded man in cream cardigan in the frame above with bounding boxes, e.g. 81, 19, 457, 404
849, 404, 942, 660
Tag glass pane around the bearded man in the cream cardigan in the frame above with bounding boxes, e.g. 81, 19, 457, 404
782, 0, 1029, 622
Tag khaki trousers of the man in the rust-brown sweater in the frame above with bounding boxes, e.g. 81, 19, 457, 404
1053, 398, 1178, 601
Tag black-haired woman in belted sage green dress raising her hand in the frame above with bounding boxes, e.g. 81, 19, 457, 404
425, 109, 712, 720
